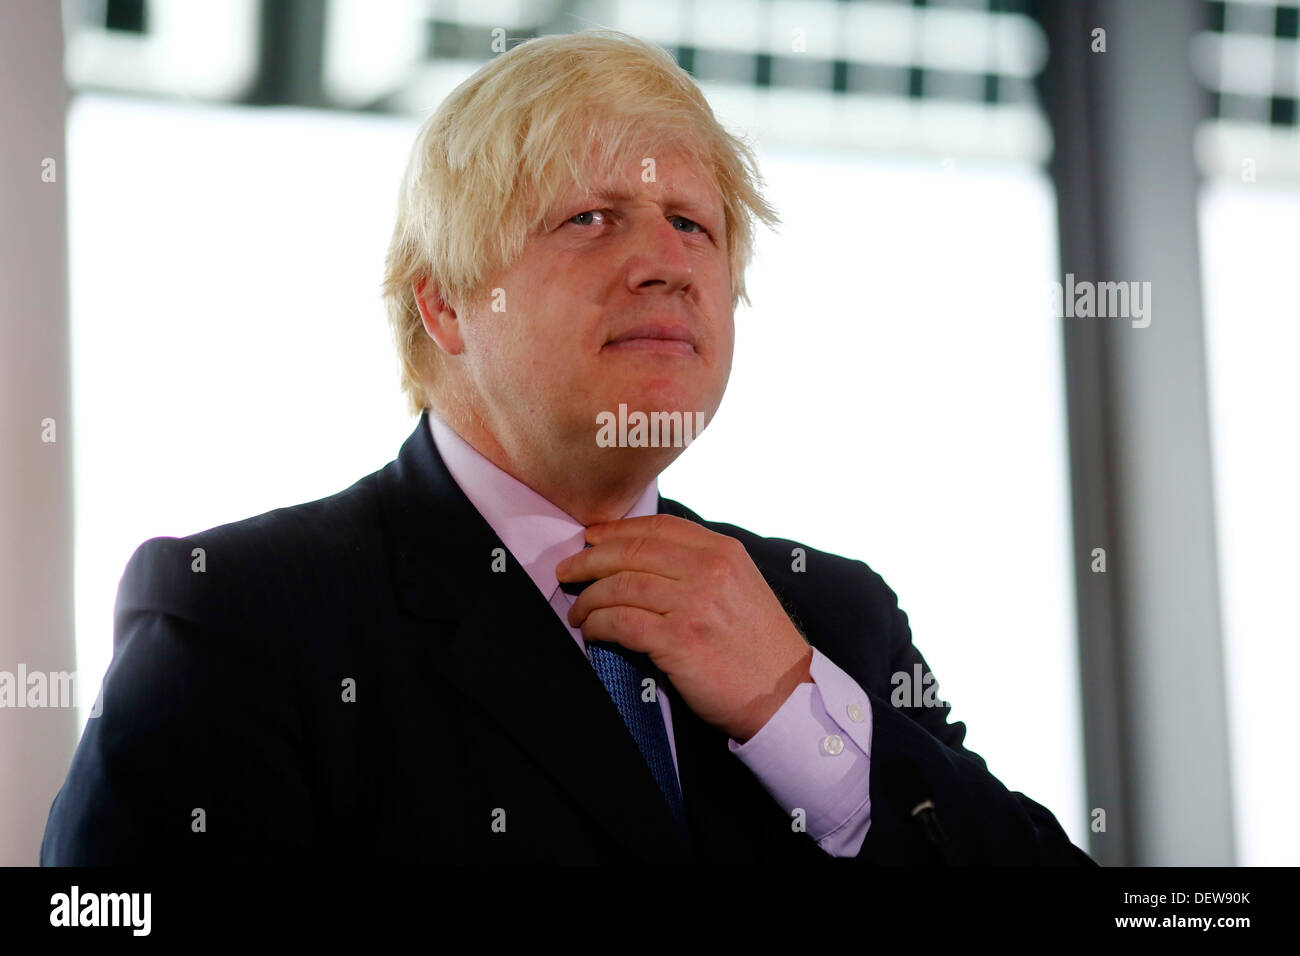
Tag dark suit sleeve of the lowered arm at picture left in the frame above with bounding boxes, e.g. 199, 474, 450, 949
40, 538, 313, 866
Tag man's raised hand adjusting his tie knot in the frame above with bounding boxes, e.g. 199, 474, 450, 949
555, 515, 813, 743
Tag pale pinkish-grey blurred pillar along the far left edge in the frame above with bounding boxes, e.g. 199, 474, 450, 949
0, 0, 78, 866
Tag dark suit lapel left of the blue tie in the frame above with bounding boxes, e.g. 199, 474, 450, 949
380, 414, 693, 864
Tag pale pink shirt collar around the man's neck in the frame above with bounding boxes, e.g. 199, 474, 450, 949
428, 408, 659, 600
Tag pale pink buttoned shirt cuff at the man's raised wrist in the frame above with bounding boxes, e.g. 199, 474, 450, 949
727, 648, 872, 856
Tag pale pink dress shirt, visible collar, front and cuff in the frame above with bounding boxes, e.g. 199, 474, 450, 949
429, 408, 871, 856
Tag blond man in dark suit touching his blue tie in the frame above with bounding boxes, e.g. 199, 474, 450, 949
42, 31, 1091, 865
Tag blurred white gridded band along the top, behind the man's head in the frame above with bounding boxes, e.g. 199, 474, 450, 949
66, 0, 1050, 161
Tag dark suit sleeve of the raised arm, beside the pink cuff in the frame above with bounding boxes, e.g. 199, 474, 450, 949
855, 572, 1096, 866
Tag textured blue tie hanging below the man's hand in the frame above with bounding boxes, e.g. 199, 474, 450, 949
560, 567, 688, 831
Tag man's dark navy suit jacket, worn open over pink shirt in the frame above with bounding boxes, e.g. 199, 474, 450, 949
40, 415, 1092, 865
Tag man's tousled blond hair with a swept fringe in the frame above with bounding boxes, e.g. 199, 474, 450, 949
382, 30, 779, 414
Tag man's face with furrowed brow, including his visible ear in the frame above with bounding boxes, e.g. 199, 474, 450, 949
458, 141, 735, 481
